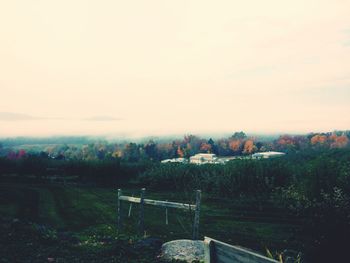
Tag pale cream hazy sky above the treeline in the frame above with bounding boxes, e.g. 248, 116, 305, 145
0, 0, 350, 136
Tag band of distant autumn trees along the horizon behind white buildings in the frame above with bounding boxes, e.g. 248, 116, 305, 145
0, 131, 350, 162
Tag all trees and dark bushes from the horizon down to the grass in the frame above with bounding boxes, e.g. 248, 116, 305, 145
0, 131, 350, 262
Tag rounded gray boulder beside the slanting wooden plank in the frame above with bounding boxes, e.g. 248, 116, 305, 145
161, 239, 204, 263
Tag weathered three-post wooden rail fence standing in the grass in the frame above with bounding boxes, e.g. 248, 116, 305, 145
117, 188, 201, 240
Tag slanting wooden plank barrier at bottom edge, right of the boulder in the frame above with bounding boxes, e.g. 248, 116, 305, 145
204, 237, 278, 263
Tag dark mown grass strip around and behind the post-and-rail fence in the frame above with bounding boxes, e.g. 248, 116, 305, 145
0, 184, 302, 262
